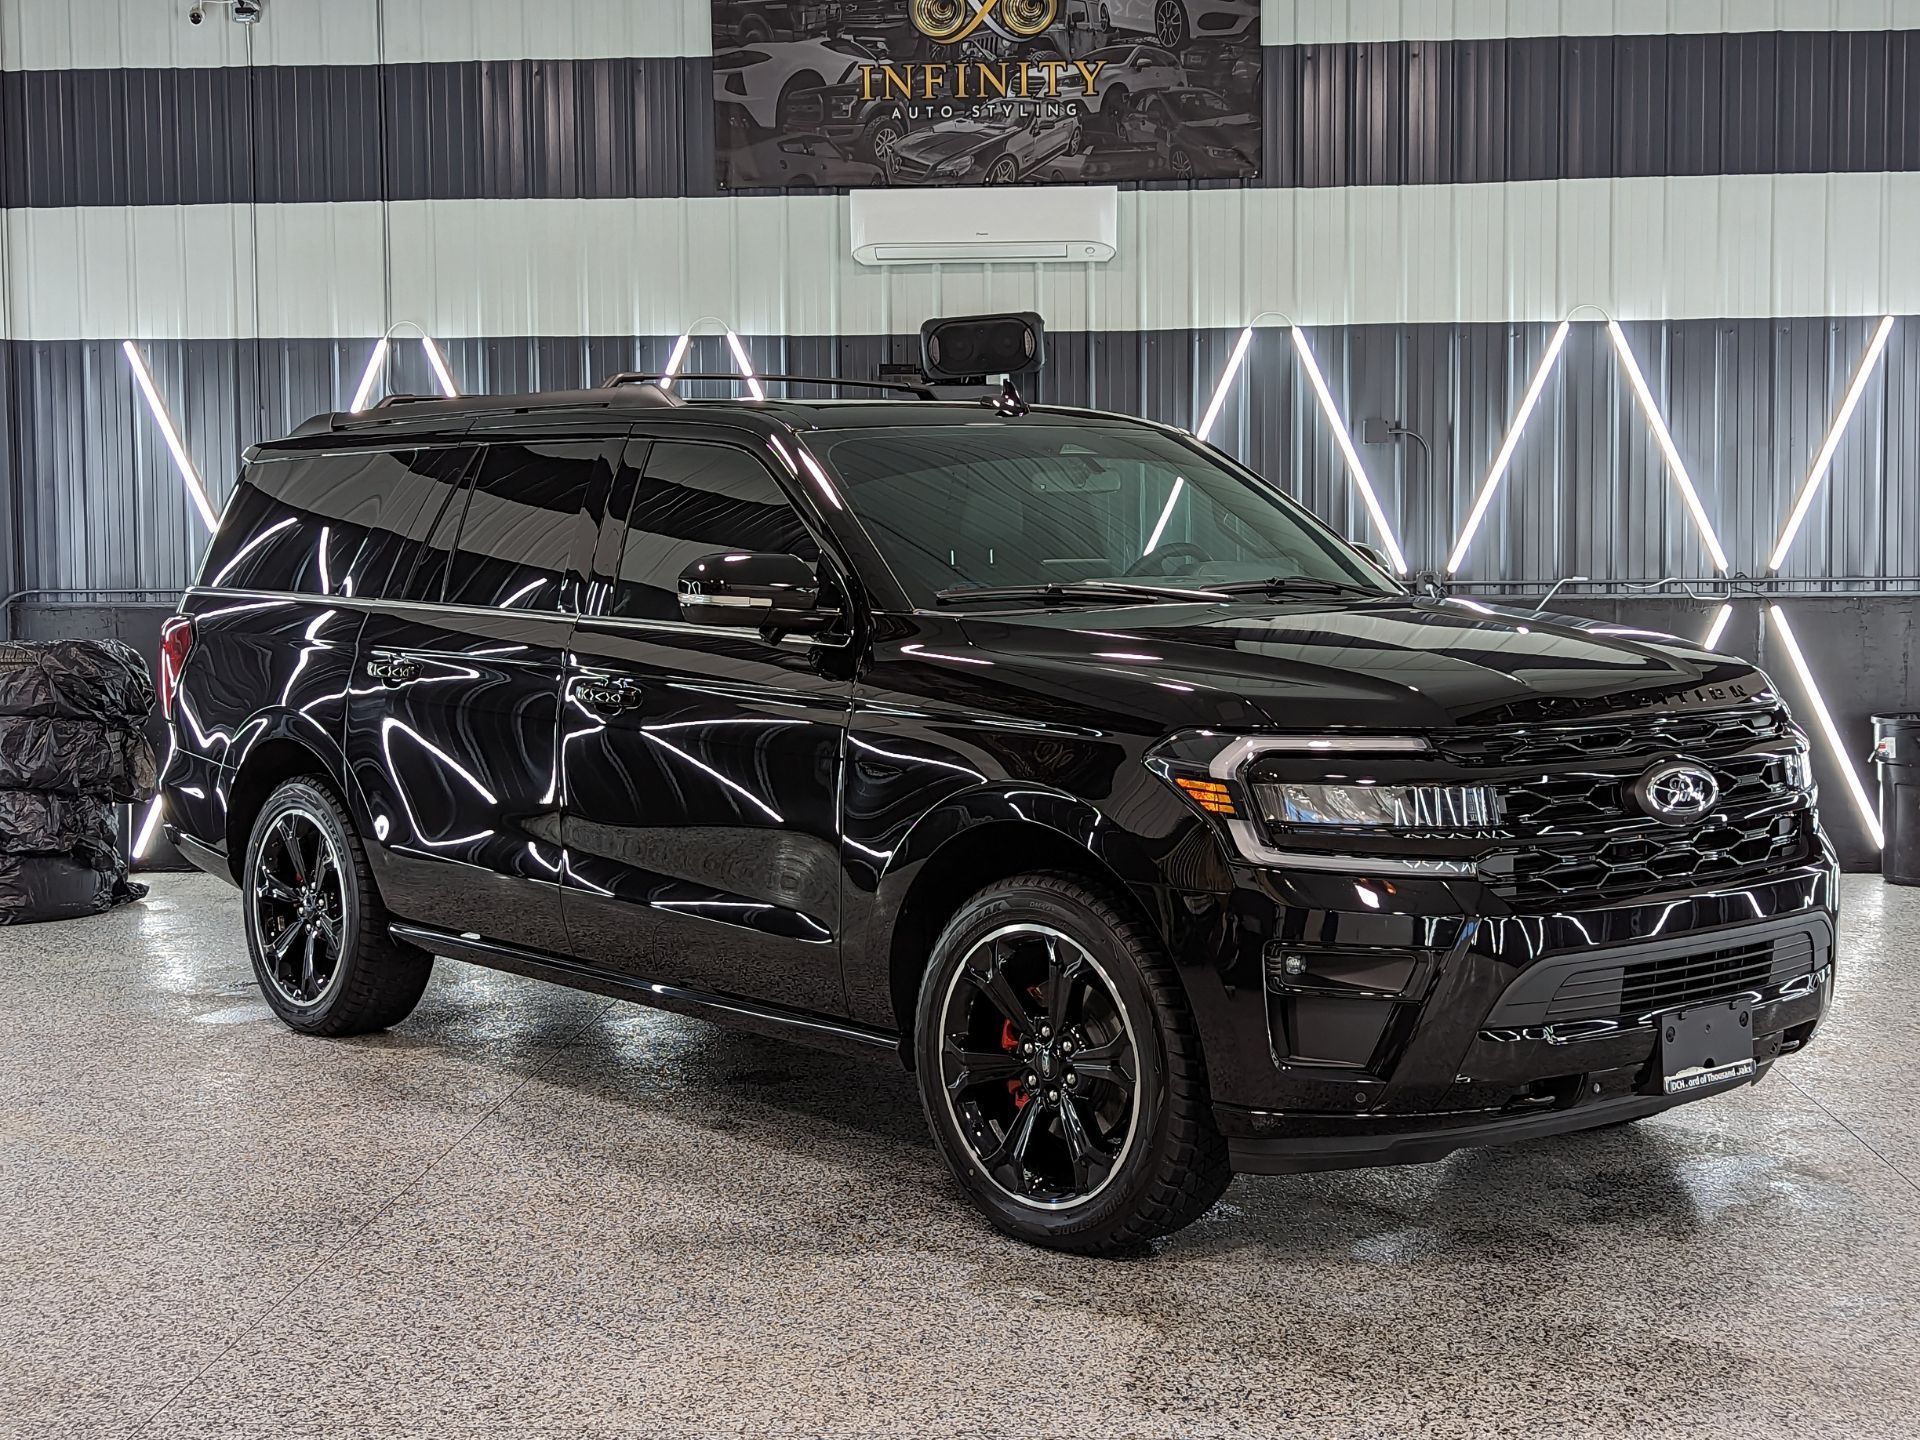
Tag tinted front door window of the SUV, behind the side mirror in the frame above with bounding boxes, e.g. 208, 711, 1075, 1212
607, 442, 820, 620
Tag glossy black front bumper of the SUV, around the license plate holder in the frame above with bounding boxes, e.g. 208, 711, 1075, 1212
1173, 852, 1837, 1173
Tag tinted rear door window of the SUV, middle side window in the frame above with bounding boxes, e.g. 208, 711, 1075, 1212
445, 442, 605, 611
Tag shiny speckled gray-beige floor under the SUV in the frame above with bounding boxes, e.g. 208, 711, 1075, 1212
0, 876, 1920, 1440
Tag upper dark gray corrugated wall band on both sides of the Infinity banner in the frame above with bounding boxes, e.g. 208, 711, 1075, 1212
0, 31, 1920, 207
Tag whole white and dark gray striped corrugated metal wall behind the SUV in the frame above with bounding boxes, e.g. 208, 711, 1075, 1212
0, 0, 1920, 589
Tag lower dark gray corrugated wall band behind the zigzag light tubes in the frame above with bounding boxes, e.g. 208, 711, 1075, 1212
6, 319, 1920, 599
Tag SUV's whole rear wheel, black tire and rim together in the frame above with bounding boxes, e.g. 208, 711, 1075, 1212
240, 776, 434, 1037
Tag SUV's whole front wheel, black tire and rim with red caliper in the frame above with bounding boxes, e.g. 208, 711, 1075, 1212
914, 874, 1233, 1256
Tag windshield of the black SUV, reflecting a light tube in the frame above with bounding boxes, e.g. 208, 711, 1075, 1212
810, 419, 1400, 605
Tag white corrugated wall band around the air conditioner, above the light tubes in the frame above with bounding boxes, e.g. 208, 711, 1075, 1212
6, 175, 1920, 340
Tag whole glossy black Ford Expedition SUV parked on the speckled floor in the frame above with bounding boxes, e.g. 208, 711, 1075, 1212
161, 382, 1836, 1252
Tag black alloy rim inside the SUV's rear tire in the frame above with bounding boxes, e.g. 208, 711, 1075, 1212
250, 804, 346, 1008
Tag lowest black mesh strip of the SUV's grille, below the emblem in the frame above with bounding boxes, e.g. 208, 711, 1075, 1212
1488, 812, 1812, 900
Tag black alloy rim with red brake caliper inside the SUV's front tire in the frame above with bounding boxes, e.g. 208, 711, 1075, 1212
941, 924, 1140, 1208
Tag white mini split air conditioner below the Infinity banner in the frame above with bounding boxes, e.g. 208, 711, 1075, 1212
852, 186, 1119, 265
